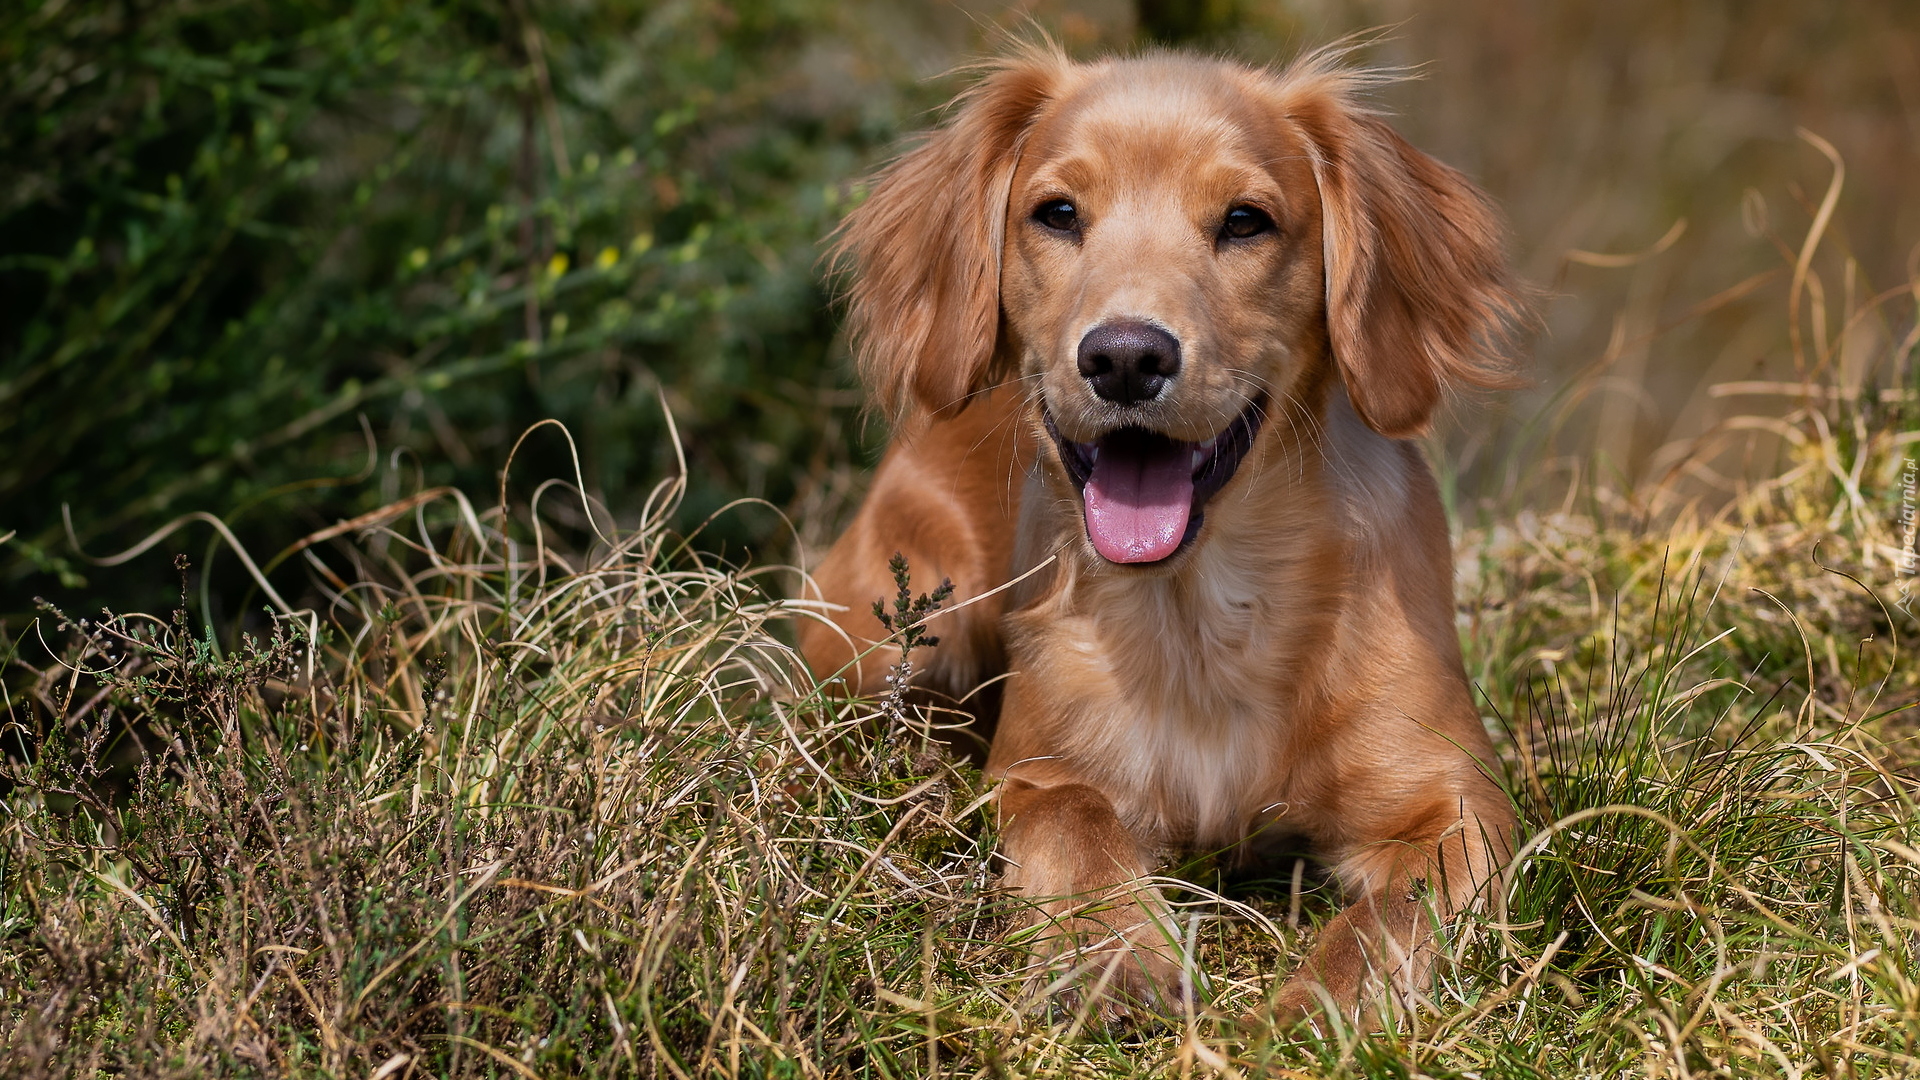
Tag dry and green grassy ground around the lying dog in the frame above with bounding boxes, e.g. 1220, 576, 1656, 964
0, 220, 1920, 1078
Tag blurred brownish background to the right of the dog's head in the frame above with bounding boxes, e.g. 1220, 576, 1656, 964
1323, 0, 1920, 480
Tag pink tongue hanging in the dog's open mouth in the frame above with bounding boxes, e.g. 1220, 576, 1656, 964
1087, 438, 1194, 563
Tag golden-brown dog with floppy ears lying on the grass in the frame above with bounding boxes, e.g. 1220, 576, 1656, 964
803, 48, 1519, 1015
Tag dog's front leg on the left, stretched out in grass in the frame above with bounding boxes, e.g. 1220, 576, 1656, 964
1000, 778, 1190, 1020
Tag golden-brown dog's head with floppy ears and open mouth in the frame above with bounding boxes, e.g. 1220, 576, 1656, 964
839, 48, 1517, 563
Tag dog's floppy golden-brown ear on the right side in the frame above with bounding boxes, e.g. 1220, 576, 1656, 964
1288, 73, 1524, 438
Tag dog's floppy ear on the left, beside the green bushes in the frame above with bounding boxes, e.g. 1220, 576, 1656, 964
831, 48, 1066, 421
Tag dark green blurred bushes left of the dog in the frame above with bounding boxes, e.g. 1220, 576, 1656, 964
0, 0, 899, 613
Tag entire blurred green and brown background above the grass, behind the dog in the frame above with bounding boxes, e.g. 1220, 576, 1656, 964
0, 0, 1920, 640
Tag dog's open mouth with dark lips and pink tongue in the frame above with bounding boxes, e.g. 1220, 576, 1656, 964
1041, 400, 1263, 563
